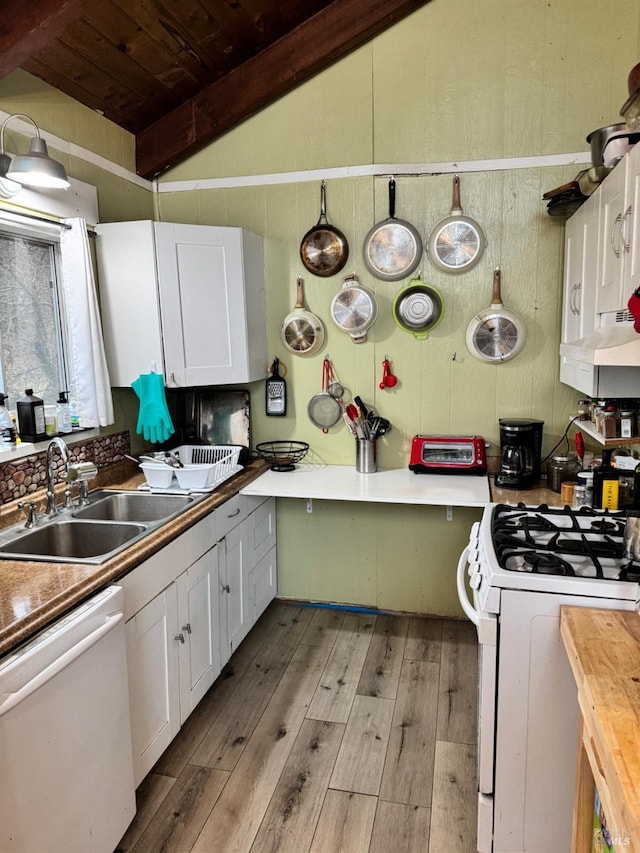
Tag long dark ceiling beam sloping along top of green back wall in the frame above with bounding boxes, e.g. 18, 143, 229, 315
136, 0, 430, 178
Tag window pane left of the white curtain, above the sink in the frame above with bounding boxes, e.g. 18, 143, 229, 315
0, 226, 69, 409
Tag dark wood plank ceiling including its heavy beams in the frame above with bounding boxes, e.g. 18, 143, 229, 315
0, 0, 429, 178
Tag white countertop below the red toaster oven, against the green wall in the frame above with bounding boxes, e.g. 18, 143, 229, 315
240, 462, 491, 507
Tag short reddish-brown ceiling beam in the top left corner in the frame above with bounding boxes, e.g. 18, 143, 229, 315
0, 0, 90, 79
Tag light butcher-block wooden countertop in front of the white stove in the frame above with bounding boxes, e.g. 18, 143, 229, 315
560, 605, 640, 850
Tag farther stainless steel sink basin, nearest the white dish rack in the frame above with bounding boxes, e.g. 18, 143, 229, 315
73, 491, 194, 524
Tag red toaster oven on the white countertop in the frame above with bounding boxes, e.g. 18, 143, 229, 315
409, 435, 487, 474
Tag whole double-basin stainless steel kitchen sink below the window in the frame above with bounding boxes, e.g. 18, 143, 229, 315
0, 489, 206, 563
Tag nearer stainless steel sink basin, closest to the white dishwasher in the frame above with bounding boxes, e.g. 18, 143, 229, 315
0, 519, 146, 561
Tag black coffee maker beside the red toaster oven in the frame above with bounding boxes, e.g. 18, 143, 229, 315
496, 418, 544, 489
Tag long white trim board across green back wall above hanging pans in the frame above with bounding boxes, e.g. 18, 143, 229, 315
157, 151, 591, 193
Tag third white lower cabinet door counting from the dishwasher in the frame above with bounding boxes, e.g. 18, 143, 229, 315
220, 520, 250, 661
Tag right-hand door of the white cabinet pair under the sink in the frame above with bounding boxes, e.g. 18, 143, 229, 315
176, 547, 220, 723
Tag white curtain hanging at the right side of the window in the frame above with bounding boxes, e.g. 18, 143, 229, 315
60, 218, 114, 428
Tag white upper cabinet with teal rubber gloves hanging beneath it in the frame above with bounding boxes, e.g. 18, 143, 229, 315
96, 220, 267, 388
